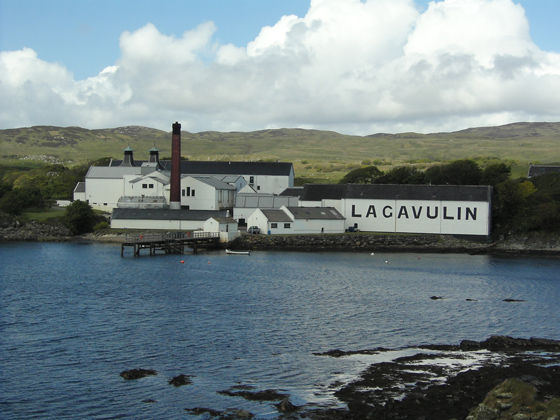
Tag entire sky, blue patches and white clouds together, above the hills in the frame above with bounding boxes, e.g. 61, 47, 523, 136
0, 0, 560, 134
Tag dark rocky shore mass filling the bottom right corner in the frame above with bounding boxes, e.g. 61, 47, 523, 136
302, 336, 560, 420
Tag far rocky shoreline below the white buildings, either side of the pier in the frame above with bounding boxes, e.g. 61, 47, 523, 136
0, 222, 560, 256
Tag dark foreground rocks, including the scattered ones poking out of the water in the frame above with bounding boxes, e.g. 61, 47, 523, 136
116, 336, 560, 420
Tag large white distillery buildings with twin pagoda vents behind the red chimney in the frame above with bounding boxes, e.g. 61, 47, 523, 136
74, 148, 294, 212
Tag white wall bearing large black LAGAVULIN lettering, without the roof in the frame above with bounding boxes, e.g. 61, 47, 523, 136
342, 199, 490, 235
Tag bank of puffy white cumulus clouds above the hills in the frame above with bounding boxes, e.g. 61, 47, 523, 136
0, 0, 560, 134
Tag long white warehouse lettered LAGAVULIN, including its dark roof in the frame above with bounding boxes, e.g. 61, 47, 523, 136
300, 184, 492, 236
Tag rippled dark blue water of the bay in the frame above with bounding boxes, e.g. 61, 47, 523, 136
0, 244, 560, 419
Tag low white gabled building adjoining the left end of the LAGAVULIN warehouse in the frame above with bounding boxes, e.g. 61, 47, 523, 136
247, 206, 345, 235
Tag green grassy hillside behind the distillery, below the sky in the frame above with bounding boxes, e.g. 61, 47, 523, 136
0, 123, 560, 182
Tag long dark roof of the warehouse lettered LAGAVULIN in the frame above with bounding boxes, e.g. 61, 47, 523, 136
300, 184, 492, 201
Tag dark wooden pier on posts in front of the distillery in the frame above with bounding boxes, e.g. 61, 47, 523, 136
121, 232, 220, 257
